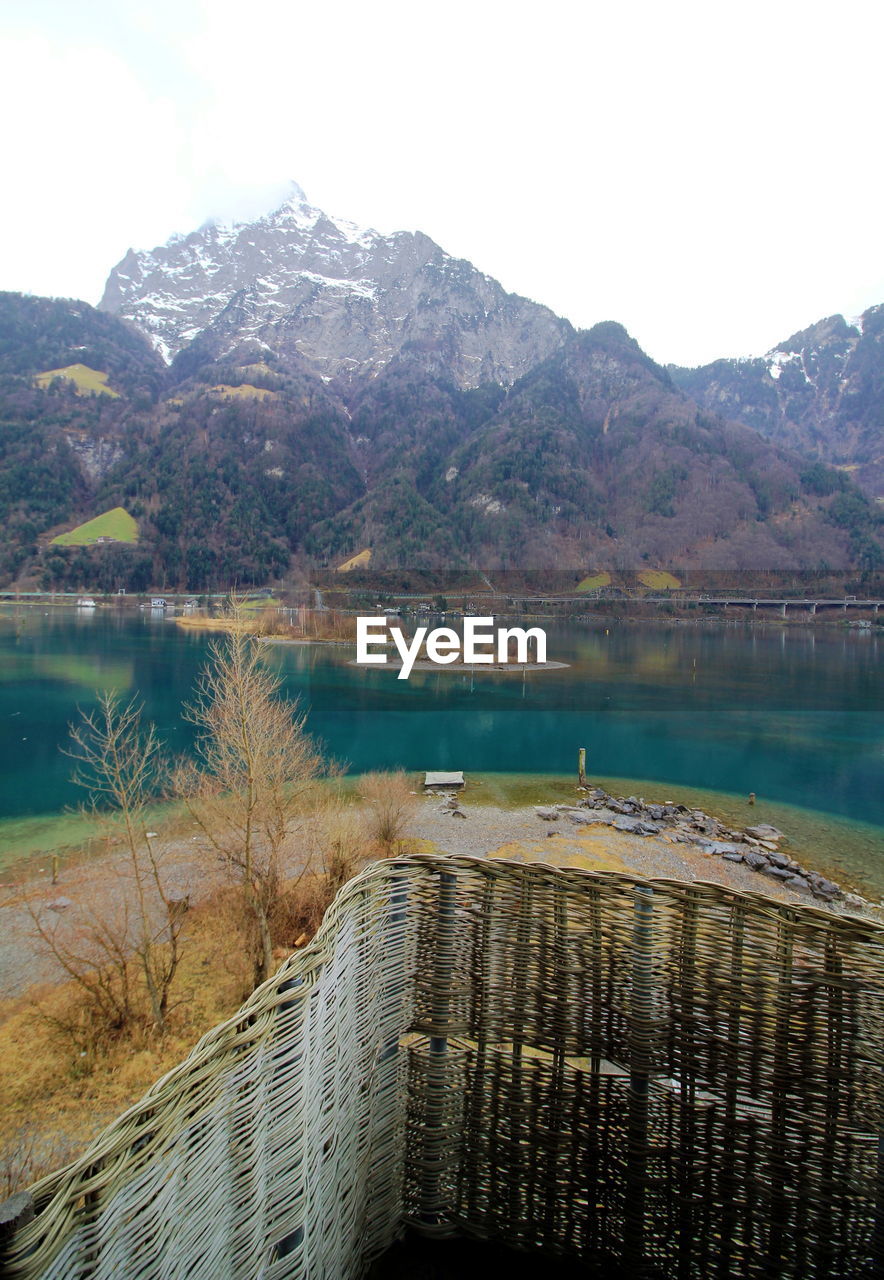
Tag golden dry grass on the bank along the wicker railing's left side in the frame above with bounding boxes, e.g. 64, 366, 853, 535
0, 834, 367, 1197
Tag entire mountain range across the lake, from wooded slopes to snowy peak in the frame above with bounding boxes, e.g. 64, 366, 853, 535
0, 188, 884, 591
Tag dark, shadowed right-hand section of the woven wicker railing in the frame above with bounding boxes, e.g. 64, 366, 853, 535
407, 863, 884, 1280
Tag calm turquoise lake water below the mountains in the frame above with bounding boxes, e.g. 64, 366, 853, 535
0, 605, 884, 880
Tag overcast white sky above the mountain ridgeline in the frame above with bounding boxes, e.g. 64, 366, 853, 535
0, 0, 884, 364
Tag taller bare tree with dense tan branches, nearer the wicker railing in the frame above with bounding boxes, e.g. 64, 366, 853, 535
177, 600, 322, 983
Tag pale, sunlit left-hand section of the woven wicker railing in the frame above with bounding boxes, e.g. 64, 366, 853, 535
6, 870, 414, 1280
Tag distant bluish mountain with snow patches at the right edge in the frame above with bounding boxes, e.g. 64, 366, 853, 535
669, 306, 884, 498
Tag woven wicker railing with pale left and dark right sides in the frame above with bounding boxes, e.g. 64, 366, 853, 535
4, 856, 884, 1280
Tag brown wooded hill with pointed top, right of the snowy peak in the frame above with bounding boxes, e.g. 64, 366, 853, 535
307, 324, 879, 570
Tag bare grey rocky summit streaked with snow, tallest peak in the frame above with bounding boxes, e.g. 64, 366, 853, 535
100, 186, 571, 387
